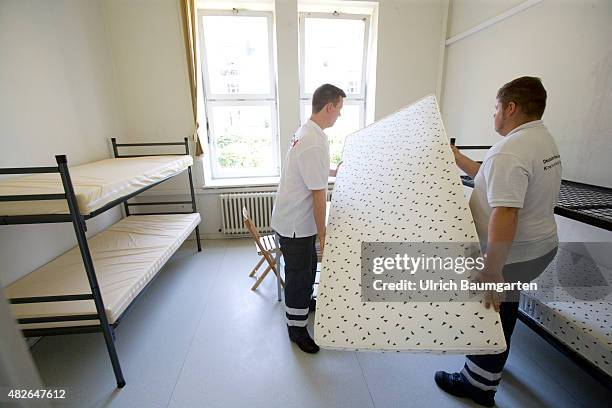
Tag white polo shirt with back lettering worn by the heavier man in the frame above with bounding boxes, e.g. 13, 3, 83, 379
470, 120, 561, 264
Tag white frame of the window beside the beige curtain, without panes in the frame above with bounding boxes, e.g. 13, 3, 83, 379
197, 9, 280, 181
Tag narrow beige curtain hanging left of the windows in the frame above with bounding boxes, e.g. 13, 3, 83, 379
179, 0, 204, 156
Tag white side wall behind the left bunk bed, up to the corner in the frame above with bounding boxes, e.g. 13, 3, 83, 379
0, 0, 121, 286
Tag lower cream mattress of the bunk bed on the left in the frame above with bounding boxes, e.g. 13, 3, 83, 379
4, 213, 200, 329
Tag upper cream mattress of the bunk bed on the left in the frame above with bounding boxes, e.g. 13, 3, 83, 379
0, 155, 193, 216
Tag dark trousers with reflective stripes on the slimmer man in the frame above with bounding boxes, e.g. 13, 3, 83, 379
279, 236, 317, 327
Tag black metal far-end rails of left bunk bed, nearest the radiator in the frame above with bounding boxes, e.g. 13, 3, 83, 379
111, 137, 202, 252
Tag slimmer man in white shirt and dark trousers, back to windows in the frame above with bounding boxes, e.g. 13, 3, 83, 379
272, 84, 346, 353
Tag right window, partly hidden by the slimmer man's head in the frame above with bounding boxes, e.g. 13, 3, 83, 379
300, 13, 369, 165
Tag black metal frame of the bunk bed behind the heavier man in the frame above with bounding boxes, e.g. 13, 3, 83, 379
451, 143, 612, 389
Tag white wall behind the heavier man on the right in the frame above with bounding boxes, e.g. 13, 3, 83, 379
443, 0, 612, 187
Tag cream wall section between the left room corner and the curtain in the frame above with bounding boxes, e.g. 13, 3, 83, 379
104, 0, 193, 142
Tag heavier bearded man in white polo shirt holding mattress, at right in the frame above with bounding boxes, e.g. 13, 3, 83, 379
435, 77, 561, 407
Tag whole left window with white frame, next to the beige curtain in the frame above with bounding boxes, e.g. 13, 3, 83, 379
198, 10, 280, 179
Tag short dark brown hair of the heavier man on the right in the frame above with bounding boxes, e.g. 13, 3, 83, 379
497, 77, 546, 119
